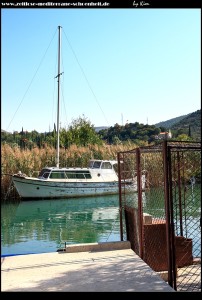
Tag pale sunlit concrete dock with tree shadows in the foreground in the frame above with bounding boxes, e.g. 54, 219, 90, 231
1, 242, 175, 292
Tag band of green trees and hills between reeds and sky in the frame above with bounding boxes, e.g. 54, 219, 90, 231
1, 110, 201, 149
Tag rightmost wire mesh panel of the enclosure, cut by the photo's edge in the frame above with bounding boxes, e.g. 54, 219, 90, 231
168, 143, 201, 292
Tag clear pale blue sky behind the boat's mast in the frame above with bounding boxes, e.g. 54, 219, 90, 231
1, 8, 201, 132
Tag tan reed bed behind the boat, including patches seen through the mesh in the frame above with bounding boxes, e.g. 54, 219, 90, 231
1, 141, 200, 201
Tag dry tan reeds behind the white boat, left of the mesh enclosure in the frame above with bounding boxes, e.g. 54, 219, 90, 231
1, 142, 137, 200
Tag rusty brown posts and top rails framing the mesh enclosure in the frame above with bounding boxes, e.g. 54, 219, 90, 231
117, 141, 201, 290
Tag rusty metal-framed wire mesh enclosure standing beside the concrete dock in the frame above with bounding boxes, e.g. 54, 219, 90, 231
118, 141, 201, 291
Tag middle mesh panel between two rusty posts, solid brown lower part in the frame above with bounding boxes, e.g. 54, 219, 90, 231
141, 148, 168, 272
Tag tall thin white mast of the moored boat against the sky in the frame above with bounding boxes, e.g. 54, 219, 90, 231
56, 26, 62, 168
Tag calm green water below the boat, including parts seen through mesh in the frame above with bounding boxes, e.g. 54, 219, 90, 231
1, 187, 201, 256
